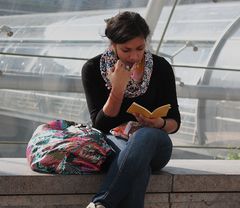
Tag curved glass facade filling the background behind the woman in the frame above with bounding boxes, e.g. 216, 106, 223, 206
0, 0, 240, 159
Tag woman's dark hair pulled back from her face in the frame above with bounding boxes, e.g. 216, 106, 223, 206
105, 11, 150, 44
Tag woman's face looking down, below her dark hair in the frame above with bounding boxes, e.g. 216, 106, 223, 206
113, 37, 146, 66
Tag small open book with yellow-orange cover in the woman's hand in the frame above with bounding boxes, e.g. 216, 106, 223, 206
127, 102, 171, 118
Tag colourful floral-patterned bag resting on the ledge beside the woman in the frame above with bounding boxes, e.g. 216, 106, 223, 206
26, 120, 112, 174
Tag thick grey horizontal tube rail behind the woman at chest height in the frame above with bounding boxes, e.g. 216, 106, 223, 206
0, 72, 240, 101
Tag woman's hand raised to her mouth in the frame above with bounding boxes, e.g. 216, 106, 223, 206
107, 60, 131, 93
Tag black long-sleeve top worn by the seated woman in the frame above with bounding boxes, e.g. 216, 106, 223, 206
82, 54, 180, 133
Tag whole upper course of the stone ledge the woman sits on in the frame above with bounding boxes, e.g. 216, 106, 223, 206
0, 158, 240, 195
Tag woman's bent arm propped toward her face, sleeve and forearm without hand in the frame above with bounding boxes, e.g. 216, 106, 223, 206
81, 56, 131, 132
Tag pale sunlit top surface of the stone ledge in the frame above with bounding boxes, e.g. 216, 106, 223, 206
0, 158, 240, 176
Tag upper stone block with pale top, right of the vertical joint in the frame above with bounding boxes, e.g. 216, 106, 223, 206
164, 160, 240, 192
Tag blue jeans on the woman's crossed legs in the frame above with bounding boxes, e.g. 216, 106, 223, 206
93, 127, 172, 208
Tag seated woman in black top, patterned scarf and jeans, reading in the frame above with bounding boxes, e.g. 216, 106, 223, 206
82, 12, 180, 208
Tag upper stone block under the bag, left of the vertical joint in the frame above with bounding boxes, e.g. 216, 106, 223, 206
0, 158, 172, 195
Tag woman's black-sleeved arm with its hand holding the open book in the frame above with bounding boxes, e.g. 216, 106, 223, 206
135, 56, 180, 133
